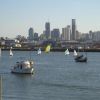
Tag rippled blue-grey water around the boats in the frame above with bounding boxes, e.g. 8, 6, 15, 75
0, 51, 100, 100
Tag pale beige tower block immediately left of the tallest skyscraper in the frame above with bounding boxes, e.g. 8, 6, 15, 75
62, 25, 71, 41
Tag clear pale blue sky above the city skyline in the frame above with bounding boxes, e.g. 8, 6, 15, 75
0, 0, 100, 38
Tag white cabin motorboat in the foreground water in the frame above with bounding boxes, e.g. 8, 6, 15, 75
11, 60, 34, 74
